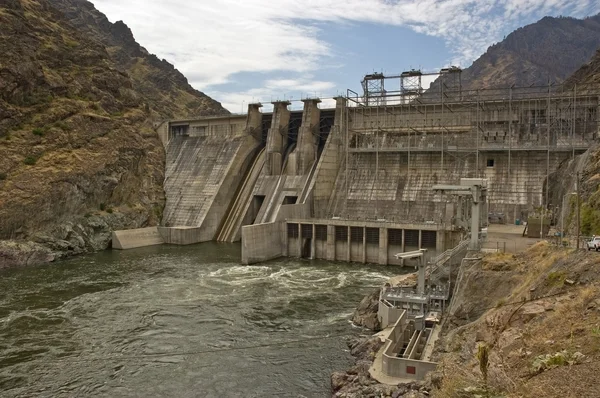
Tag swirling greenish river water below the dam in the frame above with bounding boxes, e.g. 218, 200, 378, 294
0, 244, 406, 397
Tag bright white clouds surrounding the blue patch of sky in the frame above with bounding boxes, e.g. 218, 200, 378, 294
95, 0, 600, 111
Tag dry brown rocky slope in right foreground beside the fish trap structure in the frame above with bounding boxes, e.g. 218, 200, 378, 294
432, 243, 600, 398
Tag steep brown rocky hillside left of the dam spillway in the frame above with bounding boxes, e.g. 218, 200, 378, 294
0, 0, 226, 268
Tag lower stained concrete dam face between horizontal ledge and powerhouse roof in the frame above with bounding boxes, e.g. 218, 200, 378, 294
326, 151, 571, 223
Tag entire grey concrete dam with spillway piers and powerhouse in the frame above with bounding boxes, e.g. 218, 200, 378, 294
113, 74, 600, 264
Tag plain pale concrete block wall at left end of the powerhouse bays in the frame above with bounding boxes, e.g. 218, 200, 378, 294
242, 221, 286, 264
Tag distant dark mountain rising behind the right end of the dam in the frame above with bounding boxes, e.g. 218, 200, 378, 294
432, 14, 600, 92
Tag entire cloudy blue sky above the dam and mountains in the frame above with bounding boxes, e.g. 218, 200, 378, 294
92, 0, 600, 113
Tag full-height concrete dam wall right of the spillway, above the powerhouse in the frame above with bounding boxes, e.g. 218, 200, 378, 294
314, 91, 598, 223
